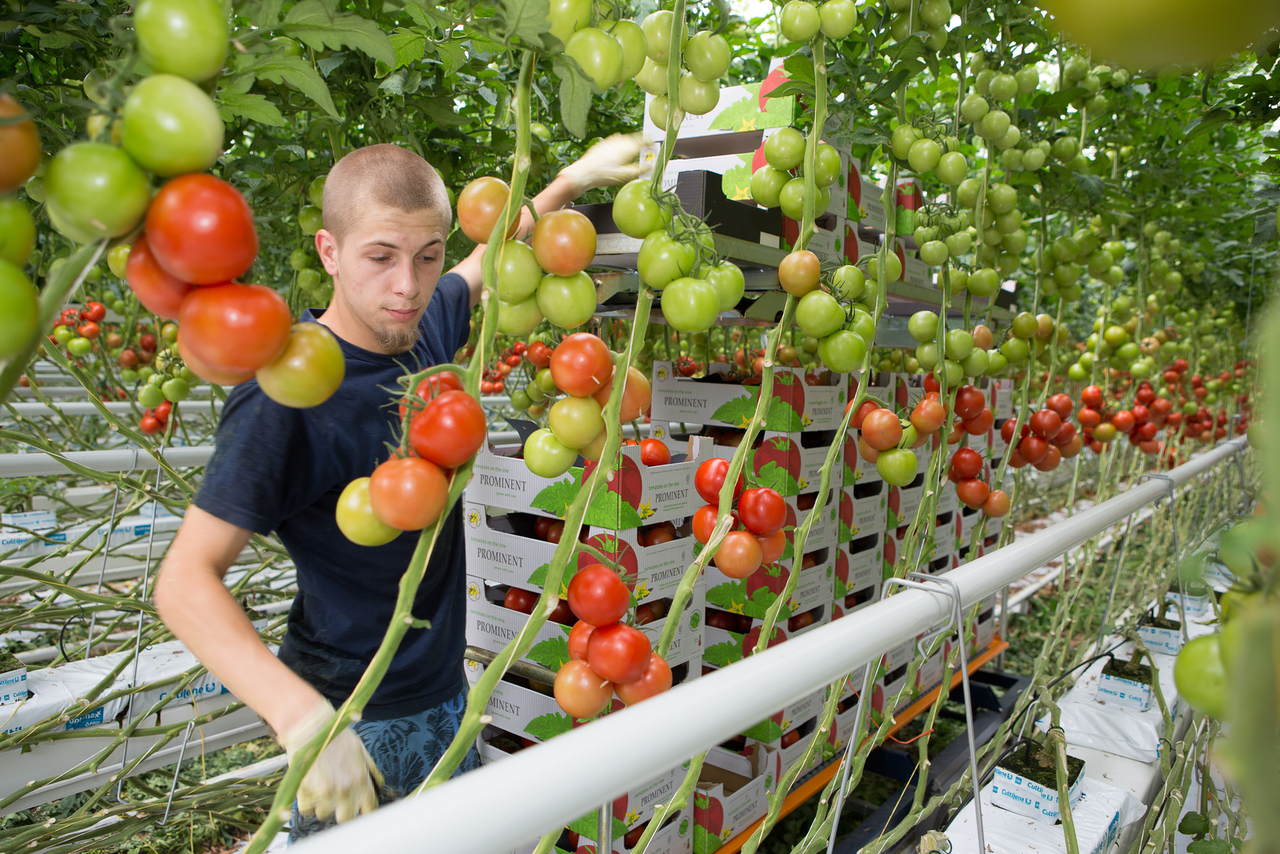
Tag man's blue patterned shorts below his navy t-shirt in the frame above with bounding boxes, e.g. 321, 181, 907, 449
289, 691, 480, 842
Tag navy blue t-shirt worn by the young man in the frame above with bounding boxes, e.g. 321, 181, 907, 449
195, 273, 470, 720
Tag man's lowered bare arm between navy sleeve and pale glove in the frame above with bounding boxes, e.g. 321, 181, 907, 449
155, 504, 323, 732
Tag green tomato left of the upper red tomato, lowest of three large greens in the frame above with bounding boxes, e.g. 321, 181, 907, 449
45, 142, 151, 243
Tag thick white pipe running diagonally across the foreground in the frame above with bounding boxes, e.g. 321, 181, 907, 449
300, 438, 1245, 854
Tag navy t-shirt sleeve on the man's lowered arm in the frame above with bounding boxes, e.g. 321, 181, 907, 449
193, 380, 329, 535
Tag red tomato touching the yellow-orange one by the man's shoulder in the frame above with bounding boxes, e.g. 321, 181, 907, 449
179, 284, 292, 373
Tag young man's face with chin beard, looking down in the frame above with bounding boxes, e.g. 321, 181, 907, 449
316, 204, 448, 353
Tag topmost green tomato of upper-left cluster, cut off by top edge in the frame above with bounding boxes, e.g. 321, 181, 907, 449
133, 0, 230, 83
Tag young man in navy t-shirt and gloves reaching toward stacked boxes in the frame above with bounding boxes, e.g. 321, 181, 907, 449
155, 136, 643, 840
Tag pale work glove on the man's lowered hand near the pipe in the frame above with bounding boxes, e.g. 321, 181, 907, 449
279, 699, 383, 822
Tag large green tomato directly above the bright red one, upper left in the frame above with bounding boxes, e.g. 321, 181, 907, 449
120, 74, 223, 178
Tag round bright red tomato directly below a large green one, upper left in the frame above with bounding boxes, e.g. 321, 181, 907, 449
144, 172, 257, 284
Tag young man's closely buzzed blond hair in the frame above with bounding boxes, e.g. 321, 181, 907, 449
323, 143, 453, 243
